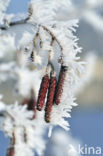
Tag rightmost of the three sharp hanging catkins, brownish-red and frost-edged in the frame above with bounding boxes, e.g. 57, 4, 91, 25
54, 65, 68, 105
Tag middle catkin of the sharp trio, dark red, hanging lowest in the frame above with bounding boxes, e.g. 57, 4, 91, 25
45, 76, 56, 122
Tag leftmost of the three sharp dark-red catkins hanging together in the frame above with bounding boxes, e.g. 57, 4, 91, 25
37, 74, 49, 111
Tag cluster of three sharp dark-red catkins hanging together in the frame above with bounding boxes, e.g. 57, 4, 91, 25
37, 63, 68, 122
